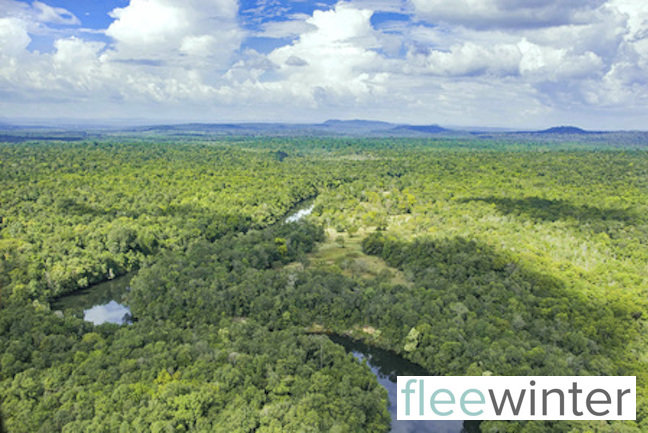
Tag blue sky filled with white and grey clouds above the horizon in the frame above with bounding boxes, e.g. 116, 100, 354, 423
0, 0, 648, 130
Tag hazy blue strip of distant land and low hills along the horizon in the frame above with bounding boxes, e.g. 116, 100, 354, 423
0, 120, 648, 147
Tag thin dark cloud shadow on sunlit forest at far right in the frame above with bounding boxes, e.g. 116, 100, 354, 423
460, 196, 640, 225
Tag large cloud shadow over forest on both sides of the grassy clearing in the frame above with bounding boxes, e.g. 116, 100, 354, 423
129, 219, 638, 375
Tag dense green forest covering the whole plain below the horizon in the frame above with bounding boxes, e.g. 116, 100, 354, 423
0, 137, 648, 433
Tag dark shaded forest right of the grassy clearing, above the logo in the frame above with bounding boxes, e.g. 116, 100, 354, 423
363, 233, 638, 375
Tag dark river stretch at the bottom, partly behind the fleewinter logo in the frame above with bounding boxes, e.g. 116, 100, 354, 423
329, 335, 479, 433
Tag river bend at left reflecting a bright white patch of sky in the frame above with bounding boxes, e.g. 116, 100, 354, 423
52, 274, 132, 325
